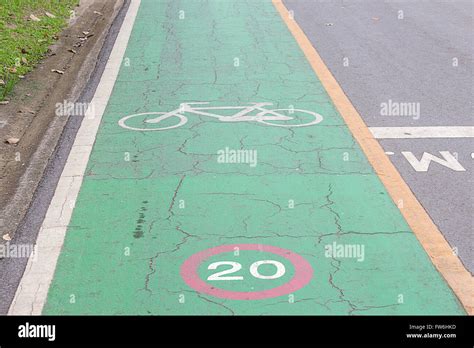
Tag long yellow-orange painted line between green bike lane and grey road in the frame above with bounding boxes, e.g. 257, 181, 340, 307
272, 0, 474, 315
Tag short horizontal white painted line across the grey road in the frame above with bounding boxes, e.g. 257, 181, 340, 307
369, 126, 474, 139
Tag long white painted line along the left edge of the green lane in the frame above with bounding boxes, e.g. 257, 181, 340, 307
8, 0, 141, 315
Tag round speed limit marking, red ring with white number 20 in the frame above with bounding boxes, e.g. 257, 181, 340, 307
181, 244, 313, 300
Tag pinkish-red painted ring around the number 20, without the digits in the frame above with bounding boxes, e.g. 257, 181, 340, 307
181, 244, 313, 300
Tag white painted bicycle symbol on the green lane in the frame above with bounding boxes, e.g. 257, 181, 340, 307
118, 102, 323, 131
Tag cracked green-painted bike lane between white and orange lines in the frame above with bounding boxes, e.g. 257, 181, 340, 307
43, 0, 465, 315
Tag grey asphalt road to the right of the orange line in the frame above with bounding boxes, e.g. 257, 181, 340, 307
284, 0, 474, 273
